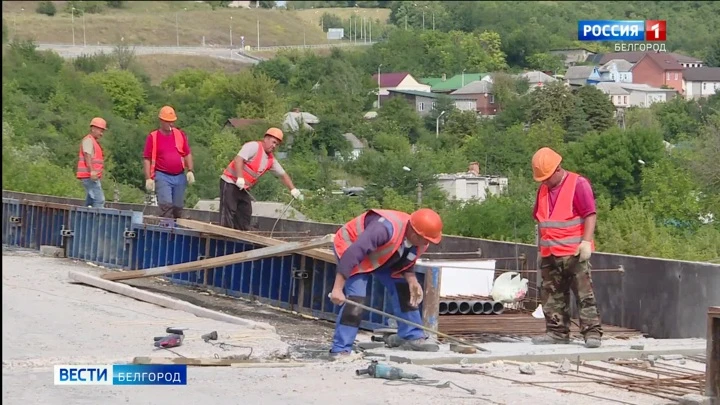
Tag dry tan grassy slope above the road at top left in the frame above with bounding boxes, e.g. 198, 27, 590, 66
2, 1, 388, 46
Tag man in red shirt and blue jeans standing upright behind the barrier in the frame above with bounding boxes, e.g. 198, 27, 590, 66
143, 106, 195, 218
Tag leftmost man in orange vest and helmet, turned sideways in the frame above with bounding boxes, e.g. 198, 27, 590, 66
76, 117, 107, 208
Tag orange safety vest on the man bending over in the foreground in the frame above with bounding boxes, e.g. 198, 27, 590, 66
334, 210, 428, 278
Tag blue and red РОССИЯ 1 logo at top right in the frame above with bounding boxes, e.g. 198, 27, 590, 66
578, 20, 667, 42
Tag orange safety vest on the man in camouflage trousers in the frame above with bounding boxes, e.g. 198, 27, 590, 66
536, 172, 595, 257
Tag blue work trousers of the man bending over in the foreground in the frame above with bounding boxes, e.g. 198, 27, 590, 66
330, 268, 425, 353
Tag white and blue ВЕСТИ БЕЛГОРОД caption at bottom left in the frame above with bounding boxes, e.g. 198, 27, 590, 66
54, 364, 187, 385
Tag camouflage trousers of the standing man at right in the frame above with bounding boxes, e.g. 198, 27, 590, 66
540, 256, 603, 339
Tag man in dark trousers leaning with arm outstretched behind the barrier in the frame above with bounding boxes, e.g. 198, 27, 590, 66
220, 128, 303, 231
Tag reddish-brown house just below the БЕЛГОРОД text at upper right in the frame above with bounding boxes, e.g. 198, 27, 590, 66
631, 52, 685, 93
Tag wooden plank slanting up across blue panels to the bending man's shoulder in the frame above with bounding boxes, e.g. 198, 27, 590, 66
102, 234, 335, 281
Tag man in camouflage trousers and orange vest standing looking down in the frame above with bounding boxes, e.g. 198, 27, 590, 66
532, 148, 603, 348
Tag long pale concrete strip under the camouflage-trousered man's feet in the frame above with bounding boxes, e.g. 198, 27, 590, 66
358, 338, 706, 365
